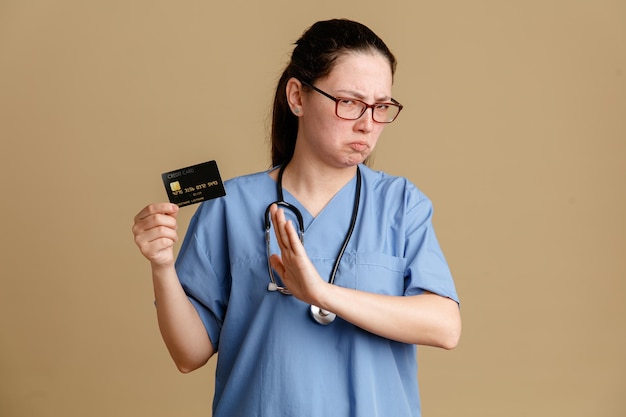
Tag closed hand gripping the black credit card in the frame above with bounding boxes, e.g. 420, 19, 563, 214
132, 203, 179, 266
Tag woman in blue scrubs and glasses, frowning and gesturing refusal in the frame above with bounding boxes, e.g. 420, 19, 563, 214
133, 19, 461, 417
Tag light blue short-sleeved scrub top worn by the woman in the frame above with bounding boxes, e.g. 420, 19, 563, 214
176, 165, 458, 417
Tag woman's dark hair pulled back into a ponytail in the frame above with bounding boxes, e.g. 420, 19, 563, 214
271, 19, 396, 166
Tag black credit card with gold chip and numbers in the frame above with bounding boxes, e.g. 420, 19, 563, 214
161, 161, 226, 207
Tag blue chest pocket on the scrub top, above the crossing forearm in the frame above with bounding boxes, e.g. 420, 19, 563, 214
354, 253, 406, 295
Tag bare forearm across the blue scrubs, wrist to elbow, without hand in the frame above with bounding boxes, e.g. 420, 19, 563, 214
319, 285, 461, 349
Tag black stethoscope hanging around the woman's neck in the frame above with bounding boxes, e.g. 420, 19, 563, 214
265, 164, 361, 324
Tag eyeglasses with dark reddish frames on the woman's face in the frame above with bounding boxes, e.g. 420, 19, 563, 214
302, 81, 403, 123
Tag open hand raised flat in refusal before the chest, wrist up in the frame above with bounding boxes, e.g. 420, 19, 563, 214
270, 204, 327, 304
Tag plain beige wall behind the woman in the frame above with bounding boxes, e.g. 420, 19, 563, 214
0, 0, 626, 417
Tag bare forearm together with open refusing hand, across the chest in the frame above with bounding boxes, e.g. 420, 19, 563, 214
270, 206, 461, 349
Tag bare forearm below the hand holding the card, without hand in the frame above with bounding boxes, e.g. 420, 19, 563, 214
152, 265, 214, 372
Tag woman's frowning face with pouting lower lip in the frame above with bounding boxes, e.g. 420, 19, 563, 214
288, 52, 392, 168
